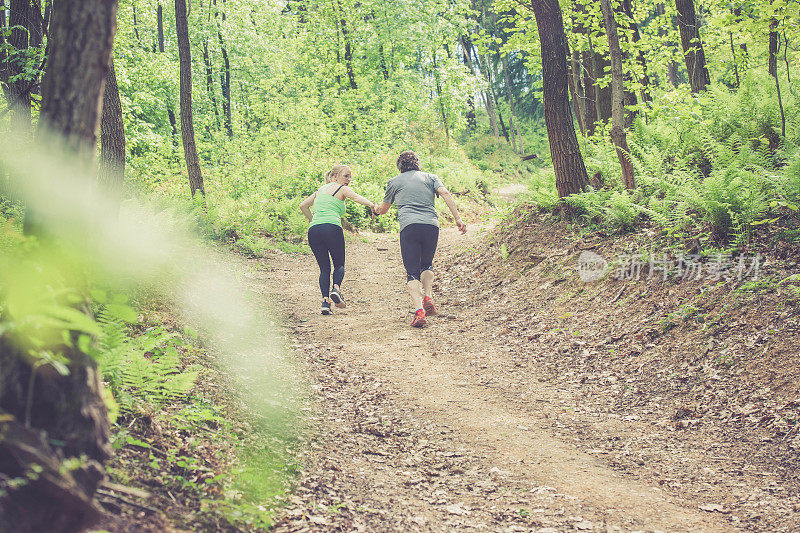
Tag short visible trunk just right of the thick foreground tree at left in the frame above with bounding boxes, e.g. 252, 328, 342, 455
99, 58, 125, 204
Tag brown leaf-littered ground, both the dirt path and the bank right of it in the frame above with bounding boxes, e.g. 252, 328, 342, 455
245, 189, 800, 532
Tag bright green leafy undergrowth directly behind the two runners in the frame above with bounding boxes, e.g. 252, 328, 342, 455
128, 129, 494, 256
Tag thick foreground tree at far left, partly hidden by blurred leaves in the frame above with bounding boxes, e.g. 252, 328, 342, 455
0, 0, 117, 531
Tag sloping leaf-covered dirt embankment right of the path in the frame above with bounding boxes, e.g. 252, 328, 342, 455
442, 209, 800, 531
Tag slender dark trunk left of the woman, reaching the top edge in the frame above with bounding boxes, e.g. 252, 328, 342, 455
175, 0, 206, 198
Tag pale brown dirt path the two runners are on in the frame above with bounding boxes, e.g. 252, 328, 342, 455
251, 228, 731, 532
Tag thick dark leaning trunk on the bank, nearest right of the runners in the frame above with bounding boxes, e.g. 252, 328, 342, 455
532, 0, 589, 198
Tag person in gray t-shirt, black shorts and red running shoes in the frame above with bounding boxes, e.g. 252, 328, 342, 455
374, 150, 467, 327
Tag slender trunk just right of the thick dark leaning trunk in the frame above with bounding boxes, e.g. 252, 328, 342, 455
600, 0, 636, 189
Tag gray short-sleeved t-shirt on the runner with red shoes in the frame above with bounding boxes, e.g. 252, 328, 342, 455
383, 170, 443, 231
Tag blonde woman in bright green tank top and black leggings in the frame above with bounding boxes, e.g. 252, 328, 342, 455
300, 165, 375, 315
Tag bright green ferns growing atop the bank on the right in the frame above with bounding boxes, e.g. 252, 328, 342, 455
529, 73, 800, 248
